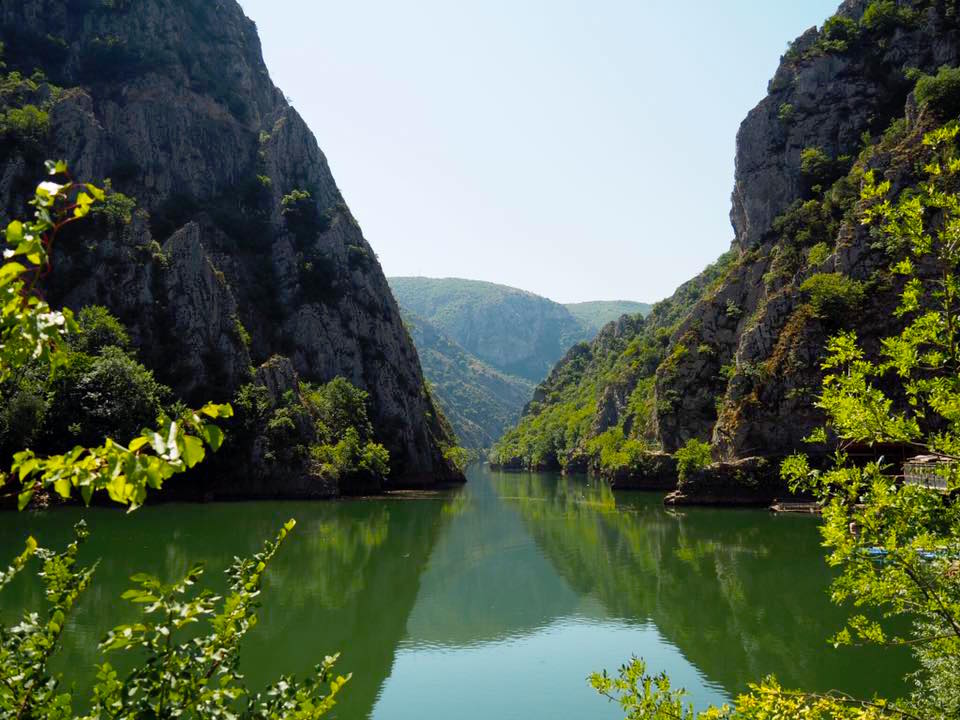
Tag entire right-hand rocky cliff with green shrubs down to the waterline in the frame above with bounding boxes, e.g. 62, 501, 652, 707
497, 0, 960, 492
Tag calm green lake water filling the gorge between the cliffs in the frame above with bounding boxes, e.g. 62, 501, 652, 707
0, 468, 910, 720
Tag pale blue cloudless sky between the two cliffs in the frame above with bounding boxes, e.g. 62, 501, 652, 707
234, 0, 839, 302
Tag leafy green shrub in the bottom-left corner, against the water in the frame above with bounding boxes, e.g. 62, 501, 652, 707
0, 521, 349, 720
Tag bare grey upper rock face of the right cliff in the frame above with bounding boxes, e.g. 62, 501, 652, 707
730, 0, 960, 250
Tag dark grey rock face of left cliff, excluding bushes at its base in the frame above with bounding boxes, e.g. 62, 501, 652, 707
0, 0, 452, 490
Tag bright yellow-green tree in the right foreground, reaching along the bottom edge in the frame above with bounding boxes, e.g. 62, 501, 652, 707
591, 123, 960, 720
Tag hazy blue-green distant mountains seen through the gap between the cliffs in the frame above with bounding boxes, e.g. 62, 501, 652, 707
388, 277, 650, 448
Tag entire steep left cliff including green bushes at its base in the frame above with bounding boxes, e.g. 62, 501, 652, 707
0, 0, 457, 496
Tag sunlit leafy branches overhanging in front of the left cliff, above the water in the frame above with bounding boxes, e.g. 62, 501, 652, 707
0, 163, 233, 509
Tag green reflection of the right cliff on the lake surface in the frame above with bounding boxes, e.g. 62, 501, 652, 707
491, 473, 910, 696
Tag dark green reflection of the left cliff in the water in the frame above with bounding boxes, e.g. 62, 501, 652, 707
0, 497, 452, 718
